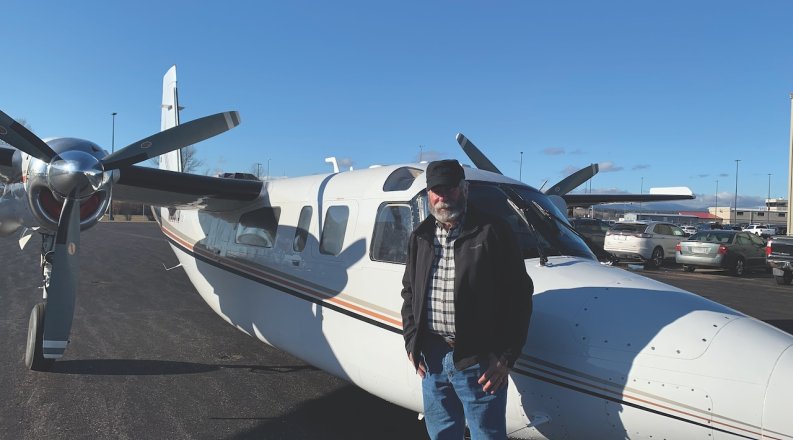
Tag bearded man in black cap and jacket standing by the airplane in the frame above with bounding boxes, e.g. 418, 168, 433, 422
402, 160, 534, 440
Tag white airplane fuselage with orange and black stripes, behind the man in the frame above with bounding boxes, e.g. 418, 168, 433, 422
161, 165, 793, 439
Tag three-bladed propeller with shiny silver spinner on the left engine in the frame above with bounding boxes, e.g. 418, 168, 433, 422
0, 107, 240, 359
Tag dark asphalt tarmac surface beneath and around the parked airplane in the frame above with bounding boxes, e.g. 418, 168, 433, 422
0, 223, 793, 439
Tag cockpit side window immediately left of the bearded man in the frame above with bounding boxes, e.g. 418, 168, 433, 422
370, 203, 413, 264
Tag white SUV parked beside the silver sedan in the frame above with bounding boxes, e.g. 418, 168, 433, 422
603, 222, 686, 268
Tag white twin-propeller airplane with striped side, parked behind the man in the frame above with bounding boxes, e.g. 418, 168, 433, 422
0, 66, 793, 439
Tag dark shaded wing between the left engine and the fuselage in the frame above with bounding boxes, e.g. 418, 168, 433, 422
113, 165, 264, 212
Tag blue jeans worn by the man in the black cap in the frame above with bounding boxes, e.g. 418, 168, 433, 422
421, 336, 507, 440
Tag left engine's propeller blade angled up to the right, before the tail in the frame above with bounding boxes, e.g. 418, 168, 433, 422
102, 112, 240, 170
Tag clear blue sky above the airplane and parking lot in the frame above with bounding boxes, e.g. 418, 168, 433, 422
0, 0, 793, 207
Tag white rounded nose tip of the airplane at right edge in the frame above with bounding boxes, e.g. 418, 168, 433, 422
763, 345, 793, 438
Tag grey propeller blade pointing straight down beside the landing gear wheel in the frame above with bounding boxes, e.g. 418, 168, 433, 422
43, 190, 80, 359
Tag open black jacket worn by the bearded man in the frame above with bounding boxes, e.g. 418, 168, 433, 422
402, 206, 534, 369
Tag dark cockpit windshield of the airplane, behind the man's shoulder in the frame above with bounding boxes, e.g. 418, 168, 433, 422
414, 181, 596, 260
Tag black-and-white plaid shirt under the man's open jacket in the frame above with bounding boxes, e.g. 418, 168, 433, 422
427, 219, 462, 340
